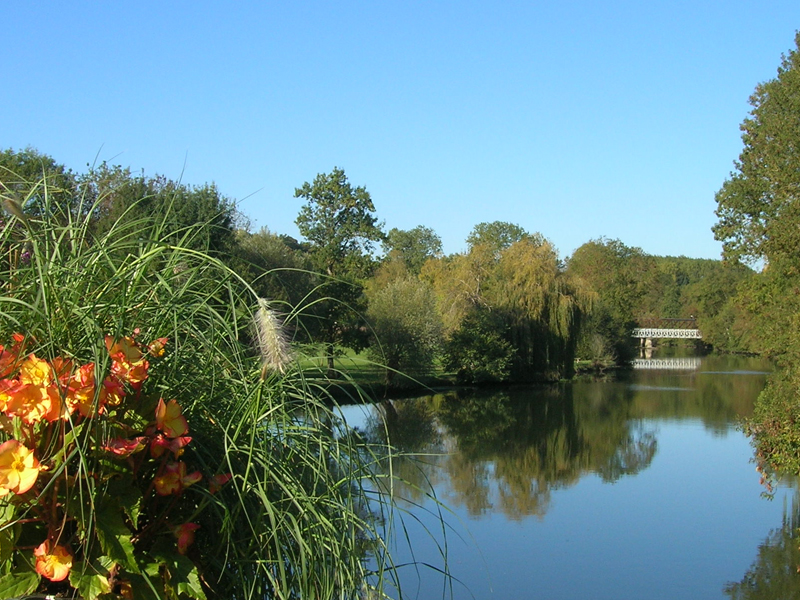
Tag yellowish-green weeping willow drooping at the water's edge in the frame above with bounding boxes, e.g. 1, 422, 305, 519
422, 227, 590, 380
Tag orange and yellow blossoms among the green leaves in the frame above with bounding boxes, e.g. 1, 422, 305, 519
0, 331, 230, 581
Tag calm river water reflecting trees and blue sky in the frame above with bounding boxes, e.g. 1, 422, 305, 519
338, 357, 800, 600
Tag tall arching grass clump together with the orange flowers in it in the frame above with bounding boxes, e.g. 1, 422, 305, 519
0, 180, 410, 600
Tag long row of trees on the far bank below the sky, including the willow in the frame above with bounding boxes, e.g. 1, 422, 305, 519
0, 149, 753, 385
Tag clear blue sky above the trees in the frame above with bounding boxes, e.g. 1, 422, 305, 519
6, 0, 800, 258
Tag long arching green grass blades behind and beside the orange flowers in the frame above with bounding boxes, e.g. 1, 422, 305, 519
0, 182, 444, 600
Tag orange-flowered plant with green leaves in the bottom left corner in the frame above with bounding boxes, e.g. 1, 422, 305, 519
0, 331, 230, 600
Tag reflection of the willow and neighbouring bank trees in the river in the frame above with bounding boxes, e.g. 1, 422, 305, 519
366, 384, 657, 519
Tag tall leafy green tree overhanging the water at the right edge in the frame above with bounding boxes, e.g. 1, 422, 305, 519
714, 33, 800, 480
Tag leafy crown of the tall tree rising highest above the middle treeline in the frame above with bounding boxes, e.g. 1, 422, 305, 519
294, 167, 384, 277
